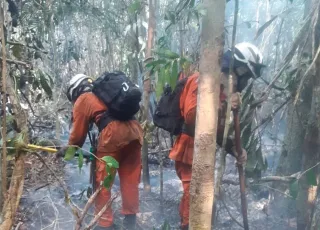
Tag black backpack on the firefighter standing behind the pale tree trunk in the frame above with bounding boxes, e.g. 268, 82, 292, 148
153, 78, 188, 135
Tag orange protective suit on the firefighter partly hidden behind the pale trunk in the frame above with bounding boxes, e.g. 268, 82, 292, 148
169, 73, 233, 229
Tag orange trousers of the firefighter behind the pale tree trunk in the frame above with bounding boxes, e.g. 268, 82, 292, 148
175, 161, 192, 228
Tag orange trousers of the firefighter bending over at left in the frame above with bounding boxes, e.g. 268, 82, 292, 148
95, 141, 142, 227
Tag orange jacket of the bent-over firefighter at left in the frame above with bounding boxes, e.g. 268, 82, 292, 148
69, 92, 143, 153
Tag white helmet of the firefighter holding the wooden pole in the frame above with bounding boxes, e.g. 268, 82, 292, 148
234, 42, 265, 78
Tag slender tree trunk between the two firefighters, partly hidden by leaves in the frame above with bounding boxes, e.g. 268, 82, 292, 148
142, 0, 156, 192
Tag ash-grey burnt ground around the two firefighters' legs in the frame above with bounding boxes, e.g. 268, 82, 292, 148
16, 149, 304, 230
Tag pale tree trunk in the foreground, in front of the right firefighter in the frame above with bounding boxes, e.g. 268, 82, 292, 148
190, 0, 226, 230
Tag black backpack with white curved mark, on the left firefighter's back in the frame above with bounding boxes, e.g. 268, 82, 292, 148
92, 71, 142, 131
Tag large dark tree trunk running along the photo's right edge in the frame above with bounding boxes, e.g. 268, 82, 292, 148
297, 0, 320, 230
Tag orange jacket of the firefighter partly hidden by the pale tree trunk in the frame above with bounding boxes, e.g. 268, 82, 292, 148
169, 73, 233, 165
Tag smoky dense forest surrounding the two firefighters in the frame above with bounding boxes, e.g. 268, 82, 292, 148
0, 0, 320, 230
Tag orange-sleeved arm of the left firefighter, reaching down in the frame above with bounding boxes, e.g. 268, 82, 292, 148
69, 104, 90, 148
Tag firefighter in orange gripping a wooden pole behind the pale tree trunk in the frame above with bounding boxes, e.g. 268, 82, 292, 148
169, 43, 264, 229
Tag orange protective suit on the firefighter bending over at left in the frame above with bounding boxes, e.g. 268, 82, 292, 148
69, 92, 143, 227
